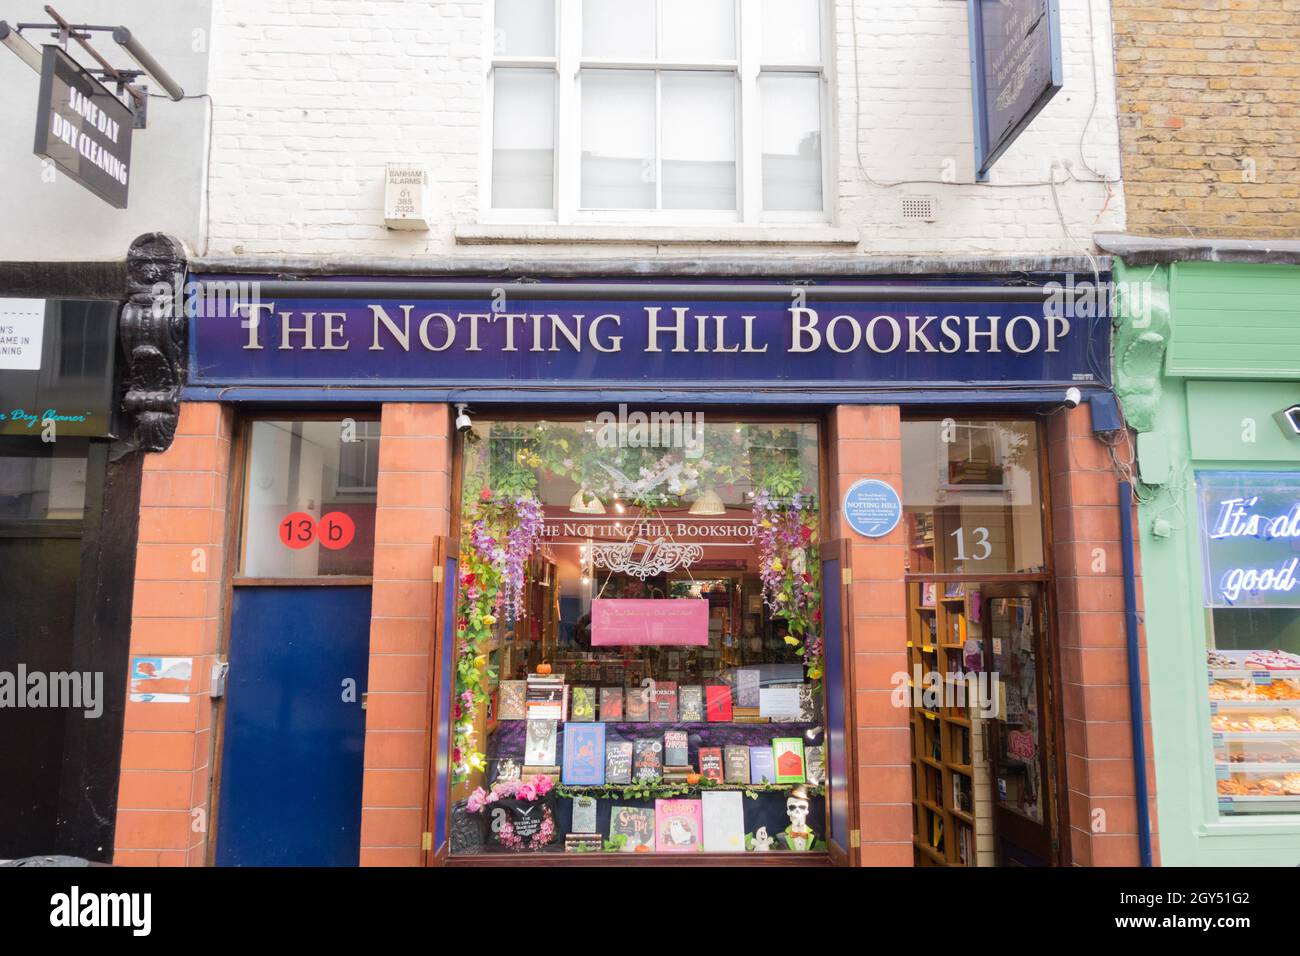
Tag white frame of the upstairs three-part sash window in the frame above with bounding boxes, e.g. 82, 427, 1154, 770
478, 0, 835, 226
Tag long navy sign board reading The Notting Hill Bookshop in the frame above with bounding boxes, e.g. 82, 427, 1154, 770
189, 277, 1110, 401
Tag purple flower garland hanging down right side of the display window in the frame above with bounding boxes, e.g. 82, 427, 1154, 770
754, 490, 824, 685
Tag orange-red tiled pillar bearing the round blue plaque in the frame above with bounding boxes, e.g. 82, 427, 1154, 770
826, 405, 913, 866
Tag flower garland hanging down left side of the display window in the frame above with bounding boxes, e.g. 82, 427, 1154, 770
451, 488, 543, 783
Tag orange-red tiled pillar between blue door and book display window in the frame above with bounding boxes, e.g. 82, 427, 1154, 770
361, 405, 451, 866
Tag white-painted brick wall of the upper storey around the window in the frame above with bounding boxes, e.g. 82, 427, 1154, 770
207, 0, 1125, 258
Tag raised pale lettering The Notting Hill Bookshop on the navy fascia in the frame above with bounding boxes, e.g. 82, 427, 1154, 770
237, 302, 1071, 355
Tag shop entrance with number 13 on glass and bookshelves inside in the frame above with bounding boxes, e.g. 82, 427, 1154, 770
902, 418, 1058, 866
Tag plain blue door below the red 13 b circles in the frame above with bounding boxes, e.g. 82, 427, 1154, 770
216, 585, 371, 866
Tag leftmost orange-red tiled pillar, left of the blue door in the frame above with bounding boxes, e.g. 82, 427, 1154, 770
113, 403, 231, 866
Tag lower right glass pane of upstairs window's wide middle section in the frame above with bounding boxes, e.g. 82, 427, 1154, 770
662, 73, 736, 209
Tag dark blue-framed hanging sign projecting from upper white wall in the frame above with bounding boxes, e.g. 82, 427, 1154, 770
967, 0, 1065, 182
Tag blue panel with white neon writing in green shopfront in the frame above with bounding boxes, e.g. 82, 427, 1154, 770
1196, 471, 1300, 607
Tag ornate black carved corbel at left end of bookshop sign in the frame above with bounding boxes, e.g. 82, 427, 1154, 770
118, 233, 186, 451
